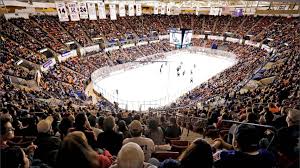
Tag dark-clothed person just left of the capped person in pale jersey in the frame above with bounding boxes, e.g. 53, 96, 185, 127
97, 116, 123, 156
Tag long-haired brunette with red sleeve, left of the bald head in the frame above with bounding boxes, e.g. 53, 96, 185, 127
55, 131, 112, 168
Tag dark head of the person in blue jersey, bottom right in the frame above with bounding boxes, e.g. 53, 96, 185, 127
235, 124, 259, 152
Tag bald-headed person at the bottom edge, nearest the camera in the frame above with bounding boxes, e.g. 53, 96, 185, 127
110, 142, 156, 168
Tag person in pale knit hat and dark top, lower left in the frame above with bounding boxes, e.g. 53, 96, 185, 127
34, 116, 61, 166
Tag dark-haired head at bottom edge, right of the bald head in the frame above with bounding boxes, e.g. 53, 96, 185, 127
179, 139, 213, 168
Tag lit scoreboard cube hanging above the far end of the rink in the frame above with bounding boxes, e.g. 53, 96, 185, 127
169, 29, 193, 48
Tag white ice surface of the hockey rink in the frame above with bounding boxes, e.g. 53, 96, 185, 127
95, 52, 236, 110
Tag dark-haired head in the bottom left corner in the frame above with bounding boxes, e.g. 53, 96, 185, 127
1, 147, 25, 168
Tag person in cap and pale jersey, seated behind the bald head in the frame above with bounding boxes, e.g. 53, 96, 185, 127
123, 120, 155, 162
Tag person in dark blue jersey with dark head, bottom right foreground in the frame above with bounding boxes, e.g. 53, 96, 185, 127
214, 124, 275, 168
